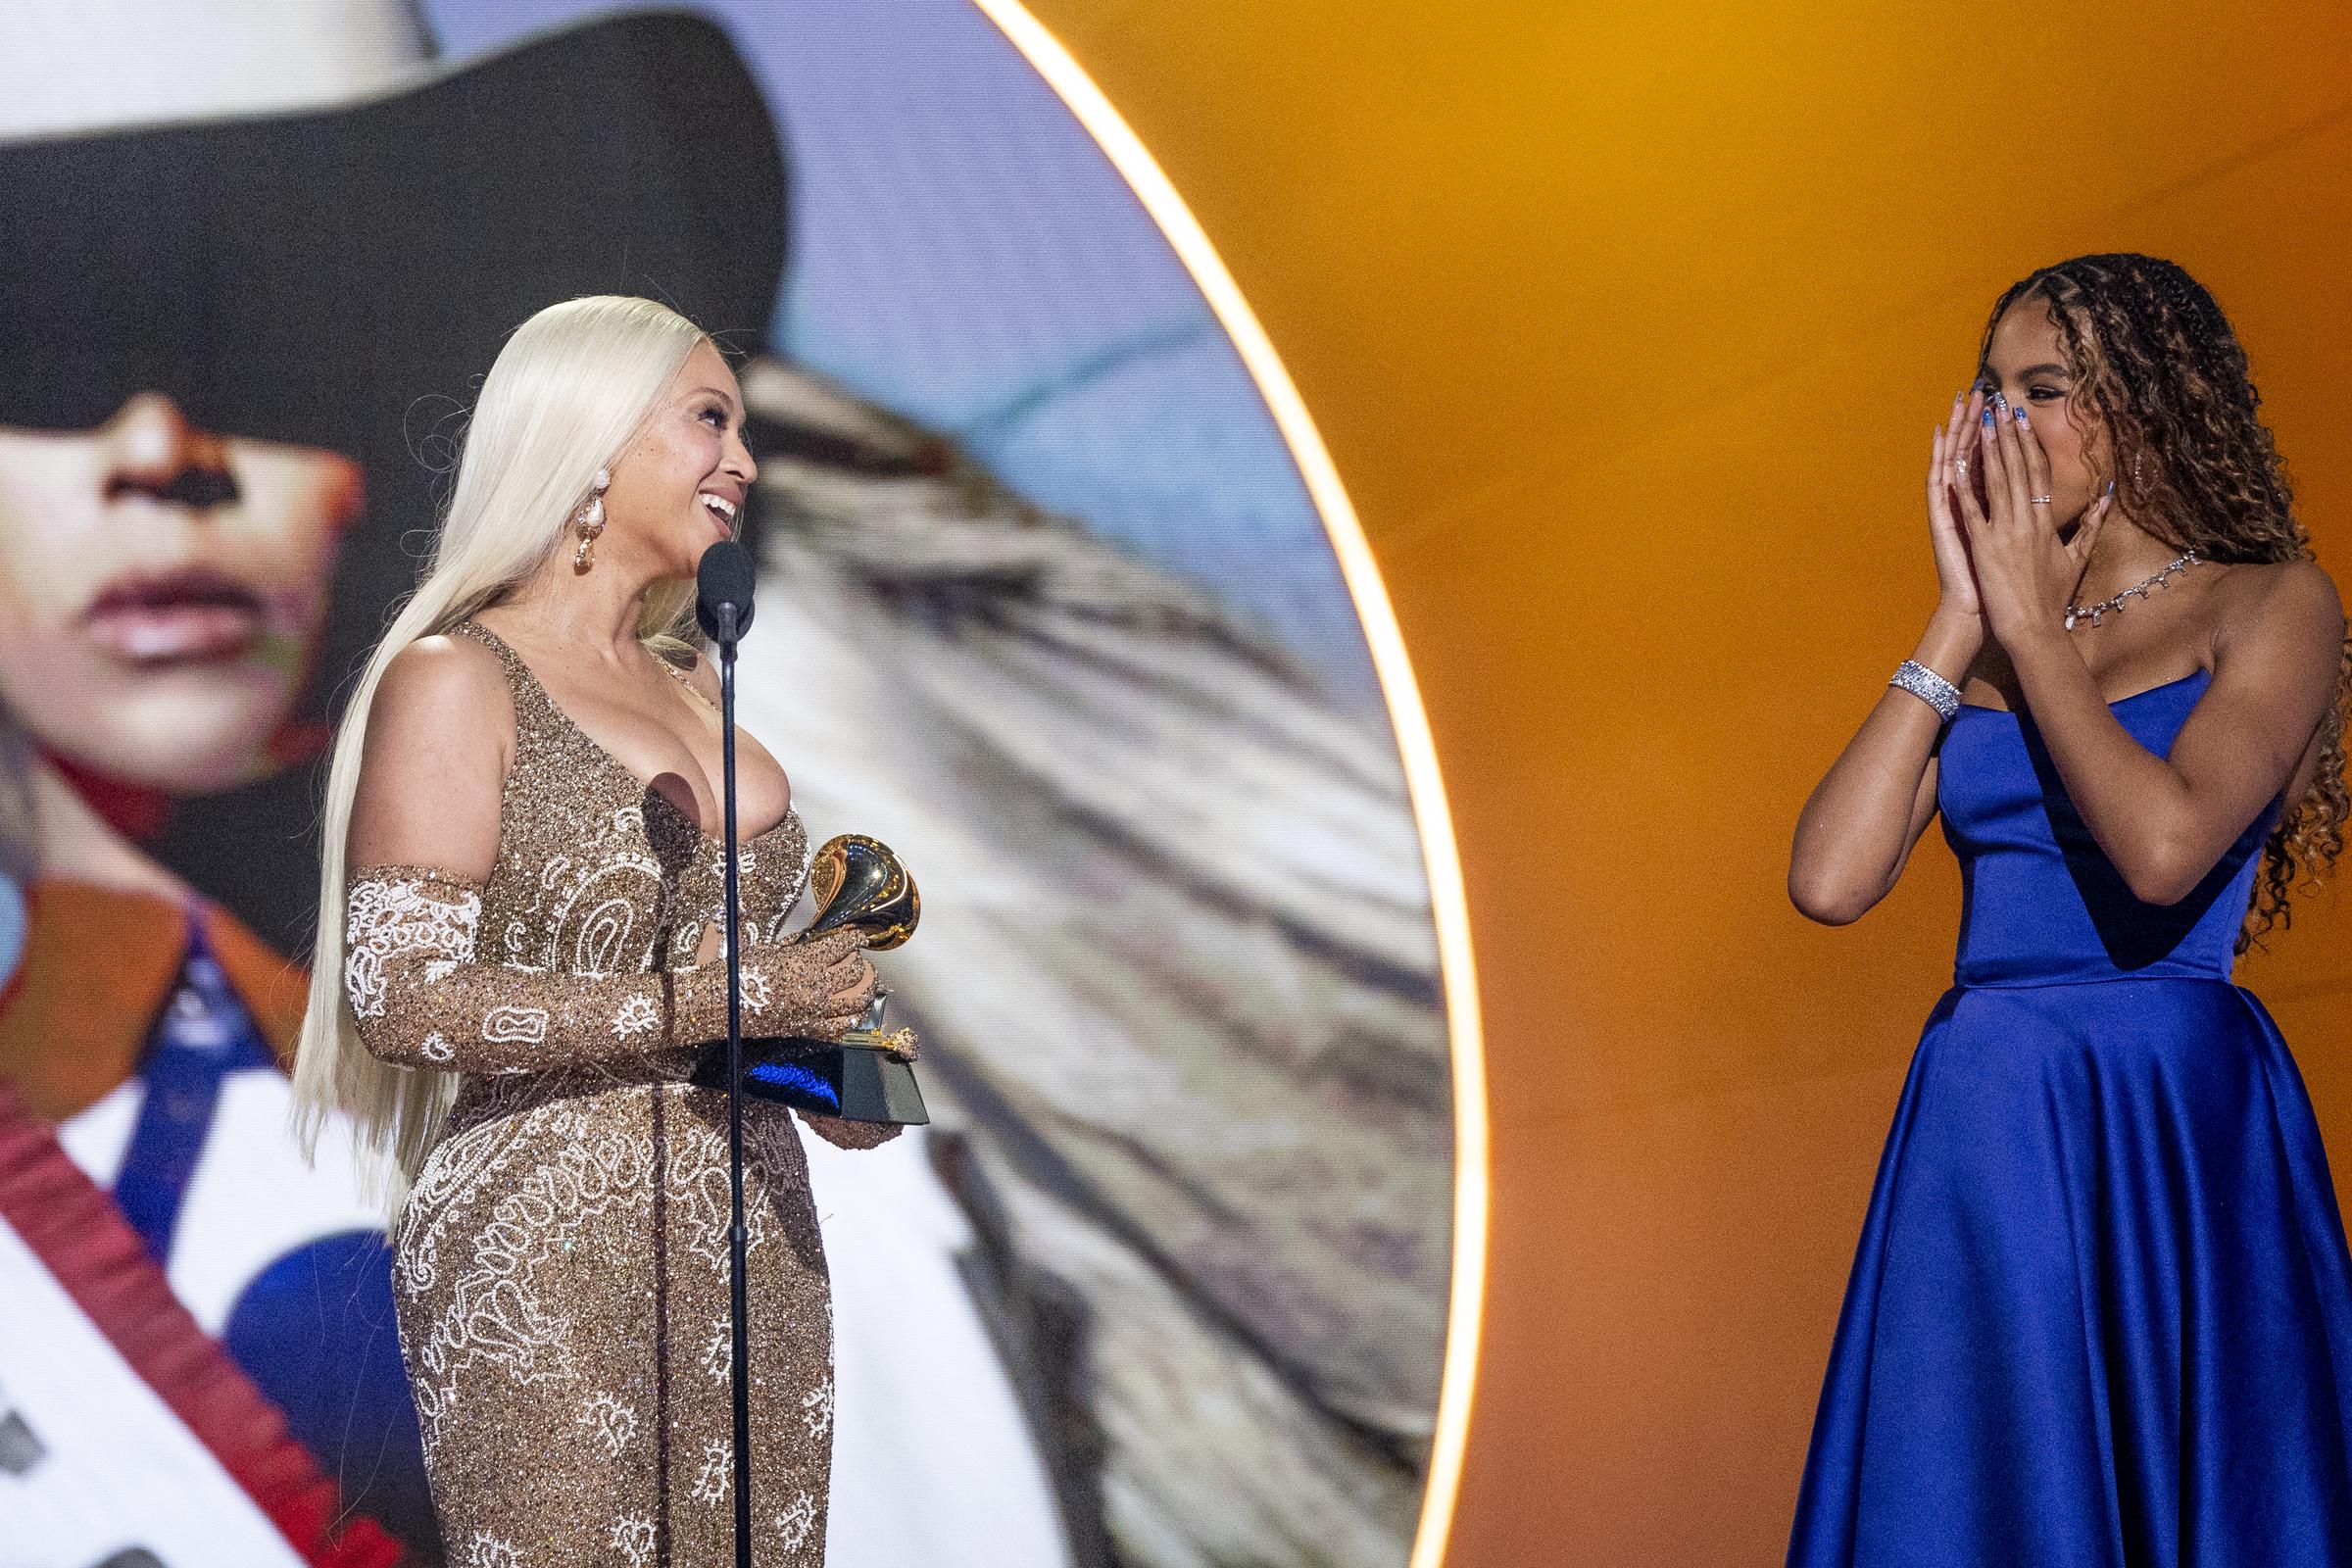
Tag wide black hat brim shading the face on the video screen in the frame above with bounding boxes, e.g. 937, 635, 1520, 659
0, 7, 786, 674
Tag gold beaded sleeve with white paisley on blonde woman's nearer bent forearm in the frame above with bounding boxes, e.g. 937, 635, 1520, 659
343, 865, 811, 1077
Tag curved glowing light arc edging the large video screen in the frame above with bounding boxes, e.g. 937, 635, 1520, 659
974, 0, 1492, 1568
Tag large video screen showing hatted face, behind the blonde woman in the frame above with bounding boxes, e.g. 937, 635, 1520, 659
0, 0, 1453, 1568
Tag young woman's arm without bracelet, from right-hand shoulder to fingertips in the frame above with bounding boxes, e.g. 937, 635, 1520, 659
1969, 404, 2345, 906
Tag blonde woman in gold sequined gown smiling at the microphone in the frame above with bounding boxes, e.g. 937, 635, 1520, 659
296, 299, 894, 1568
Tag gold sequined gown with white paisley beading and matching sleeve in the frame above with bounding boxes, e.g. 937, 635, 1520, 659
346, 623, 887, 1568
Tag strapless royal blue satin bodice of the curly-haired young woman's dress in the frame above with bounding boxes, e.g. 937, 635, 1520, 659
1936, 670, 2277, 985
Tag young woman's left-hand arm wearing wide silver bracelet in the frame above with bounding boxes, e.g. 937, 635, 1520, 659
1788, 393, 1985, 926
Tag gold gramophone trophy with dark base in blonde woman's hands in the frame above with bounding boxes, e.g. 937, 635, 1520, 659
694, 832, 931, 1121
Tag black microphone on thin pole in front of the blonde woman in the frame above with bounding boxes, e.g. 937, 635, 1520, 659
694, 538, 753, 1568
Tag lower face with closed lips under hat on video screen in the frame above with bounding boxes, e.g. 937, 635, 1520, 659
0, 393, 360, 795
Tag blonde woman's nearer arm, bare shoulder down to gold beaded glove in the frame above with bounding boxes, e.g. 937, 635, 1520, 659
343, 637, 872, 1072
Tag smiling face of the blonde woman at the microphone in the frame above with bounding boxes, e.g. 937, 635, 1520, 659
598, 343, 760, 576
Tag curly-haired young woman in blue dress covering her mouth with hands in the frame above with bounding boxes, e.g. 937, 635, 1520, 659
1789, 254, 2352, 1568
